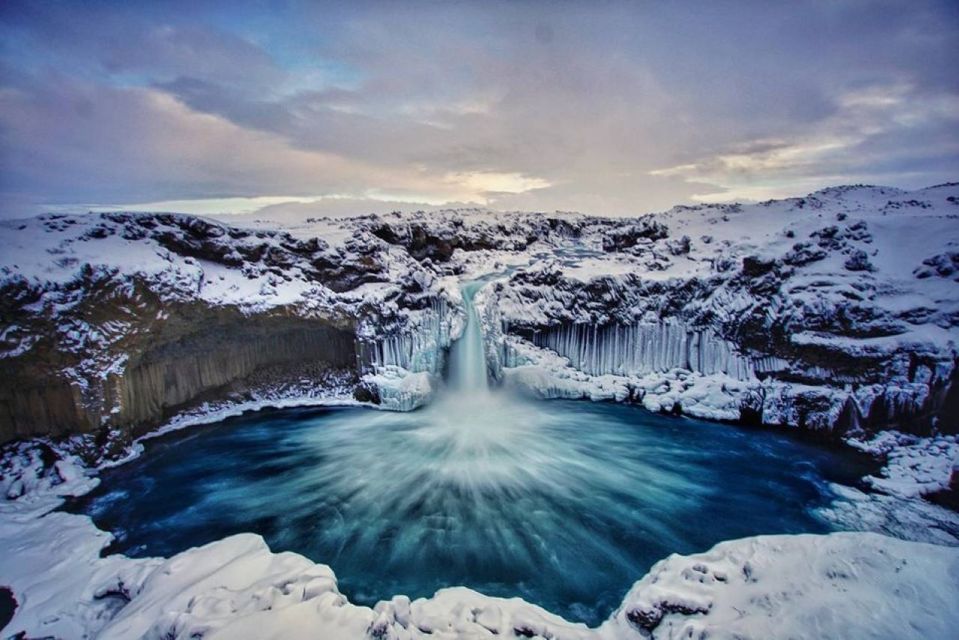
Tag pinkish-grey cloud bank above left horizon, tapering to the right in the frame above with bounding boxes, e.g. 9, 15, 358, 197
0, 76, 549, 216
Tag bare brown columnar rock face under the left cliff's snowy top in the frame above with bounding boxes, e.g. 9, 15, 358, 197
0, 306, 356, 442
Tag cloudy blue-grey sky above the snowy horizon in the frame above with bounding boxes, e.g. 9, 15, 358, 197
0, 0, 959, 218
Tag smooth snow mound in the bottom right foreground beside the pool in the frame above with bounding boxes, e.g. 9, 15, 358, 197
607, 533, 959, 640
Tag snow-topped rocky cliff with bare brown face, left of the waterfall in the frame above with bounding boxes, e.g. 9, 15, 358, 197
0, 213, 436, 442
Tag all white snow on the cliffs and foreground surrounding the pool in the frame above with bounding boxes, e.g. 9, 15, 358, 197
0, 185, 959, 639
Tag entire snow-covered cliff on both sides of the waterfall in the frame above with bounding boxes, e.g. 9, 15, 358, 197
0, 184, 959, 448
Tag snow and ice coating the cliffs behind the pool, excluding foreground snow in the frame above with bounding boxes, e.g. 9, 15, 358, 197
0, 185, 959, 426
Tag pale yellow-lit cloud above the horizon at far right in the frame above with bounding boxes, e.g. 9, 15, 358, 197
650, 83, 959, 202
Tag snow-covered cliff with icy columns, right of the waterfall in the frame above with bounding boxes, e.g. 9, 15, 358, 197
487, 184, 959, 434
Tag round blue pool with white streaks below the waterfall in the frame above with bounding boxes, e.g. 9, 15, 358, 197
70, 396, 869, 624
